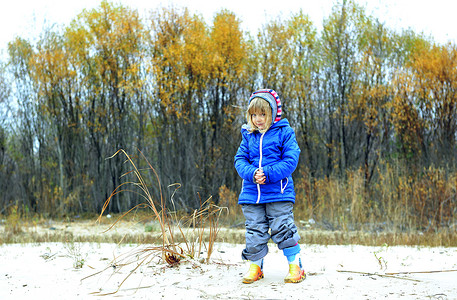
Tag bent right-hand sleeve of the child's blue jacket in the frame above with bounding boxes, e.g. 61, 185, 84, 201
263, 127, 300, 183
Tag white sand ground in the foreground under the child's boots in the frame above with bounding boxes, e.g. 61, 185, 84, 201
0, 243, 457, 300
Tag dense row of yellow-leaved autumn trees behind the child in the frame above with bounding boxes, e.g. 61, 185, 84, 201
0, 0, 457, 232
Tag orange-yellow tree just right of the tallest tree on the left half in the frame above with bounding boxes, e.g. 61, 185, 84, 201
146, 8, 208, 206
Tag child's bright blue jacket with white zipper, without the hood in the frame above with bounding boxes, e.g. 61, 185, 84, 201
235, 119, 300, 204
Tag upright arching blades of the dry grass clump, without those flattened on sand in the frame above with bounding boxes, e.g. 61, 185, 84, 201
97, 149, 223, 264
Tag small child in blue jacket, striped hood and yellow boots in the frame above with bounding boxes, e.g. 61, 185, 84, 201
235, 90, 306, 283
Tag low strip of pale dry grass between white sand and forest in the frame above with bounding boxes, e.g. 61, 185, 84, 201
0, 220, 457, 247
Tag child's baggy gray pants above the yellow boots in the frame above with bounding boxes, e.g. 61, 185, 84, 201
241, 202, 300, 260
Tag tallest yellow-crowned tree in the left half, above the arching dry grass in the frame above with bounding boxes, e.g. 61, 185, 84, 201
65, 1, 146, 211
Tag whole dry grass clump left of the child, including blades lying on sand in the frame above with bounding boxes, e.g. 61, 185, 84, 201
80, 149, 228, 295
